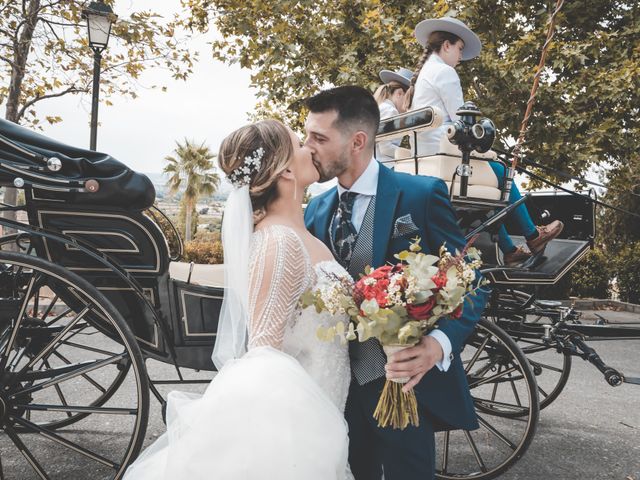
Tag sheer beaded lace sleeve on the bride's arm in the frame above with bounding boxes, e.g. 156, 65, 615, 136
249, 226, 310, 349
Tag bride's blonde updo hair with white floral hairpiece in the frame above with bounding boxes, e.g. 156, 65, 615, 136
218, 120, 293, 223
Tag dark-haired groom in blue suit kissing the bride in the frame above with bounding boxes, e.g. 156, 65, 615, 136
305, 86, 486, 480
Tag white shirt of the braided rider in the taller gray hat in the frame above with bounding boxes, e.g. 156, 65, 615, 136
411, 53, 464, 155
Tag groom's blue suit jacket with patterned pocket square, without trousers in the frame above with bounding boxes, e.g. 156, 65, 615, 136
305, 165, 487, 429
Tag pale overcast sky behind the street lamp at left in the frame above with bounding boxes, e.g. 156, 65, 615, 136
28, 0, 256, 173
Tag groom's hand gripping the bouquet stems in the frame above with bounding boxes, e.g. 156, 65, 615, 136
385, 335, 444, 392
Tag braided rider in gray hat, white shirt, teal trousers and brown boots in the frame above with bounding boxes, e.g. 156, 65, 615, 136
404, 17, 564, 265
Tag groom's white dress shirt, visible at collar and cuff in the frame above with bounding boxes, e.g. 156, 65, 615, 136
338, 158, 452, 372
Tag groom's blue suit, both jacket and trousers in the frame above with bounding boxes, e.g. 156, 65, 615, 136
305, 165, 486, 480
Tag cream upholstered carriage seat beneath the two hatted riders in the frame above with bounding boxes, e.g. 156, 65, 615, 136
394, 136, 502, 200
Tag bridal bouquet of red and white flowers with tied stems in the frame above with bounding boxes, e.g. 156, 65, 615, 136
302, 238, 481, 429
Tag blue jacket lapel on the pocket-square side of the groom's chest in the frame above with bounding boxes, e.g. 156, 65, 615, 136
372, 164, 400, 268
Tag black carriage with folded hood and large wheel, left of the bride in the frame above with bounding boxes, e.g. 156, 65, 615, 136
0, 121, 223, 478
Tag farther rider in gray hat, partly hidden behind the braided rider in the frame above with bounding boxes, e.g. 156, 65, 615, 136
373, 68, 413, 163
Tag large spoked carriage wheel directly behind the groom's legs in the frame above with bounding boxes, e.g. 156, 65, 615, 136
436, 319, 540, 479
